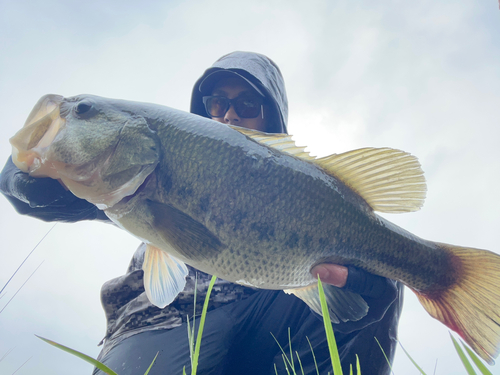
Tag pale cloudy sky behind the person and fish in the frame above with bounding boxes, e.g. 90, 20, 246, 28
0, 0, 500, 375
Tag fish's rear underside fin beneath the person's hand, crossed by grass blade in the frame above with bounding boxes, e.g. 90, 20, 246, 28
284, 284, 368, 324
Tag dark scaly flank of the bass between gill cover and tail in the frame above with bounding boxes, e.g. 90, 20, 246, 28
146, 110, 458, 290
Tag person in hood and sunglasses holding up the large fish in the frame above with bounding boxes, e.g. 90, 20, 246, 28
0, 52, 402, 375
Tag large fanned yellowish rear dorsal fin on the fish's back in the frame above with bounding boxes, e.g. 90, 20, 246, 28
314, 148, 427, 213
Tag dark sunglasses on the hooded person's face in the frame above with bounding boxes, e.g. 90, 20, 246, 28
203, 96, 264, 118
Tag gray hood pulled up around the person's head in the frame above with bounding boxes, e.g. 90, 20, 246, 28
191, 52, 288, 133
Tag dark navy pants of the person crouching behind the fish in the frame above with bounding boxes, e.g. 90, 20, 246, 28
93, 290, 401, 375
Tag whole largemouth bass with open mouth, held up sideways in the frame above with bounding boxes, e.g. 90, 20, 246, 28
11, 95, 500, 363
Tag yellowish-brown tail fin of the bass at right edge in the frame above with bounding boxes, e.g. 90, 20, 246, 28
415, 244, 500, 364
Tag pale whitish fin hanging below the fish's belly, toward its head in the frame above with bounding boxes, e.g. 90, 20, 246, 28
142, 245, 188, 309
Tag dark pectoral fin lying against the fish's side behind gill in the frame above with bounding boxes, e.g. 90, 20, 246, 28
147, 200, 225, 261
